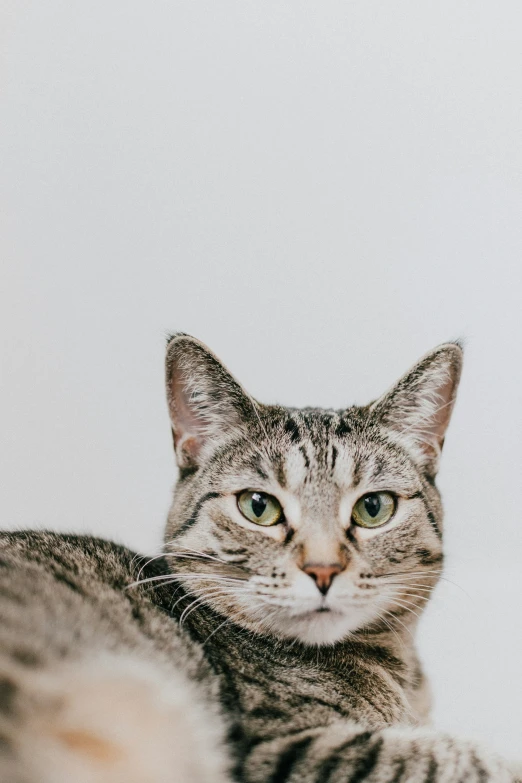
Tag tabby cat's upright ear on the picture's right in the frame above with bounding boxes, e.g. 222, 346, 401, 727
371, 343, 463, 476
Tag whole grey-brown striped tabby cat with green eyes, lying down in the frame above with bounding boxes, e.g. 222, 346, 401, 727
0, 334, 522, 783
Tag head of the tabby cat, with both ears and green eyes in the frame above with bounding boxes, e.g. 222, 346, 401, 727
165, 334, 462, 645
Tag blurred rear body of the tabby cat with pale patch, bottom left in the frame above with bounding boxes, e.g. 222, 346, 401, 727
0, 531, 229, 783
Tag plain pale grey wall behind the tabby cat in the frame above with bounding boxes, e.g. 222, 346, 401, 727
0, 0, 522, 756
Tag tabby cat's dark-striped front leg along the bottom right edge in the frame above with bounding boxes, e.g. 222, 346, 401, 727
243, 722, 522, 783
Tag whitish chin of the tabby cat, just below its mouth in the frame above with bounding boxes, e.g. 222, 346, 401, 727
254, 610, 369, 647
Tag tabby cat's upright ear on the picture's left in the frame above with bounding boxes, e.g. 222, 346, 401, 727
166, 333, 257, 469
